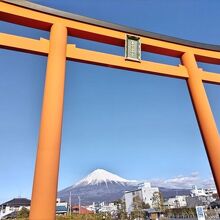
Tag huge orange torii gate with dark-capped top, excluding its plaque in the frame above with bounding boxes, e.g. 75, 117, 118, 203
0, 0, 220, 220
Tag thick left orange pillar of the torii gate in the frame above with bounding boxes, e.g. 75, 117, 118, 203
30, 24, 67, 220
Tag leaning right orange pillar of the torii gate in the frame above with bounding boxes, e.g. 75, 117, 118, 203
182, 53, 220, 195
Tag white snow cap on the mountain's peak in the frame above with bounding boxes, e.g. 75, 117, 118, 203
76, 169, 133, 185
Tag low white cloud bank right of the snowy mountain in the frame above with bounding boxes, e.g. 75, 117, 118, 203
150, 172, 215, 188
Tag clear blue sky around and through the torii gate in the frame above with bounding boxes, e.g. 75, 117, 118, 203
0, 0, 220, 201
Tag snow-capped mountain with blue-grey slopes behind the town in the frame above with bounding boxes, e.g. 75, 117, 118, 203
58, 169, 190, 205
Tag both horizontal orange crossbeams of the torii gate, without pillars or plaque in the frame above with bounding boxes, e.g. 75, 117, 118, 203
0, 0, 220, 84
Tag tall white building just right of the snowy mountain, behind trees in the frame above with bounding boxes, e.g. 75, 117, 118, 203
124, 182, 159, 214
